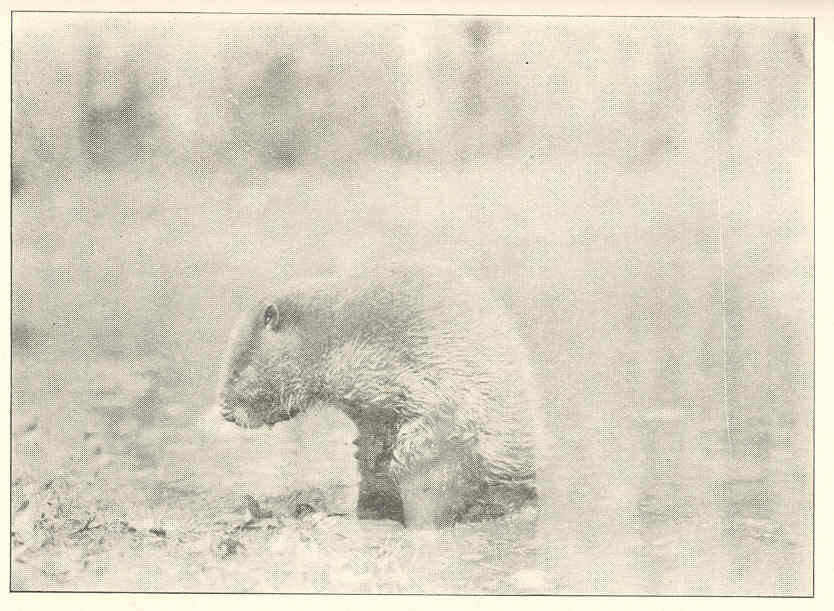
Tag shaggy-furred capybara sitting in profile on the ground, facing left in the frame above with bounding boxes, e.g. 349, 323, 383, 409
218, 262, 538, 528
